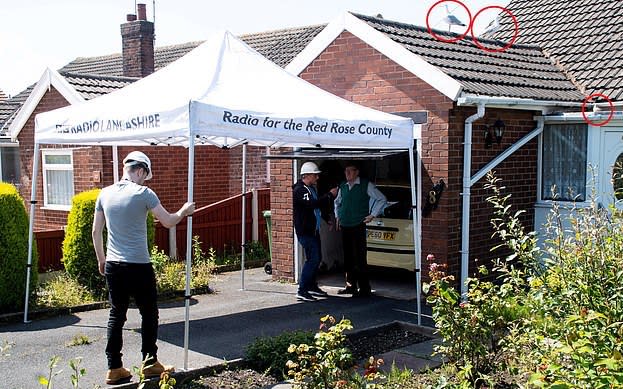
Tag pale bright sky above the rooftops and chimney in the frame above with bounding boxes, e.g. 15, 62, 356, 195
0, 0, 510, 96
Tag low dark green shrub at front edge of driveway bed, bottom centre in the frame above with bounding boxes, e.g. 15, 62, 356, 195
245, 331, 314, 380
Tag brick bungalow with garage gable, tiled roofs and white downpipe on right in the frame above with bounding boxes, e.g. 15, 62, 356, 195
271, 4, 623, 292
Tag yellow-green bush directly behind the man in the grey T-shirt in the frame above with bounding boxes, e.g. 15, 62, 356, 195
62, 189, 106, 294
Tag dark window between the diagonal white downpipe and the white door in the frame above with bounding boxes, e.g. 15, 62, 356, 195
541, 124, 587, 201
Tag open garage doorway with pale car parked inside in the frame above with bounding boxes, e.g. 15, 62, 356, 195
265, 149, 419, 300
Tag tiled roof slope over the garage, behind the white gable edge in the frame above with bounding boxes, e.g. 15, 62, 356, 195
354, 14, 583, 101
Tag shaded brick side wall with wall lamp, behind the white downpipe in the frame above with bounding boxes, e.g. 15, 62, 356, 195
444, 107, 538, 279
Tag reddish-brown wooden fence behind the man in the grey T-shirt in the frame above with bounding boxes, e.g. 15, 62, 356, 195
35, 189, 270, 273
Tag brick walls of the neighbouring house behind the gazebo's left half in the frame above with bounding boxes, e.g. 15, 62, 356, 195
18, 87, 268, 230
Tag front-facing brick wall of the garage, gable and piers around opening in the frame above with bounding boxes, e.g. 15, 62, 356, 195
271, 32, 453, 278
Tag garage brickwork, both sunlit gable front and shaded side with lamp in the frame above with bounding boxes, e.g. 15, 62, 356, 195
271, 32, 536, 280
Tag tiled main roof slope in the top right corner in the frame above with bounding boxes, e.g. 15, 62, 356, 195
490, 0, 623, 101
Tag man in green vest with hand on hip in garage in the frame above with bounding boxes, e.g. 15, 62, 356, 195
334, 162, 387, 297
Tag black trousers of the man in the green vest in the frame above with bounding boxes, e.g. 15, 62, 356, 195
341, 223, 371, 293
